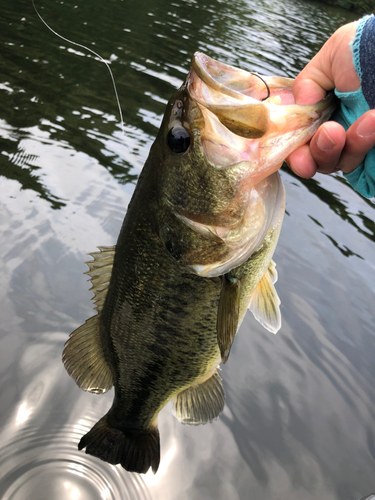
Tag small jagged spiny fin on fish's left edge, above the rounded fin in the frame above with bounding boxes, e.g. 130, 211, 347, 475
85, 246, 115, 313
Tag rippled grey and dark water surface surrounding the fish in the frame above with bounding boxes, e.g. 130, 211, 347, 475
0, 0, 375, 500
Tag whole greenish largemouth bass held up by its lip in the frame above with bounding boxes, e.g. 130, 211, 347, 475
63, 52, 335, 473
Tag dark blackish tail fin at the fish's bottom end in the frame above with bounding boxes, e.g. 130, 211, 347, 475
78, 415, 160, 474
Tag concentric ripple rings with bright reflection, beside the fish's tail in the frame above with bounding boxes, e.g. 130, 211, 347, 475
0, 424, 151, 500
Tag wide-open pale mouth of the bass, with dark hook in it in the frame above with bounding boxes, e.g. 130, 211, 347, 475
186, 52, 335, 144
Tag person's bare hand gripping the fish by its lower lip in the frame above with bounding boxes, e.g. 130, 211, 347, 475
287, 23, 375, 178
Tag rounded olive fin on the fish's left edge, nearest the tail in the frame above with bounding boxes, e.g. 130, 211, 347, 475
62, 315, 113, 394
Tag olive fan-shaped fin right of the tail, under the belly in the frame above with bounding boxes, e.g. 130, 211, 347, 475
173, 368, 225, 425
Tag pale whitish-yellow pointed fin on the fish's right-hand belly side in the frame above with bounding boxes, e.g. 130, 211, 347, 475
249, 261, 281, 333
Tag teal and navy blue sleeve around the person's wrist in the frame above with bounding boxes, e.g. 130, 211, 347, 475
334, 15, 375, 198
